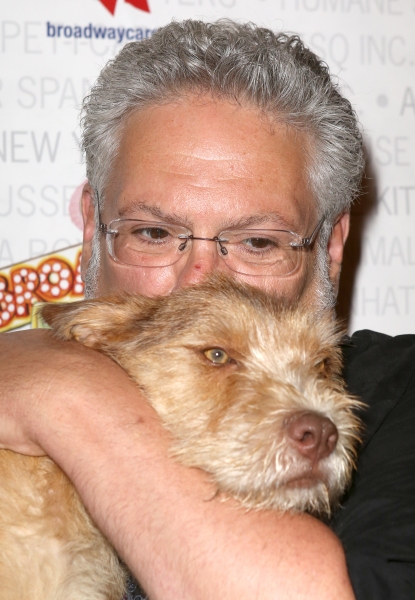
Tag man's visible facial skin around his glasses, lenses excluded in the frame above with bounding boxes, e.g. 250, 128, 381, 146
83, 98, 340, 304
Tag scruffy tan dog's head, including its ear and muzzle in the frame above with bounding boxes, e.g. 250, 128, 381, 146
44, 277, 359, 513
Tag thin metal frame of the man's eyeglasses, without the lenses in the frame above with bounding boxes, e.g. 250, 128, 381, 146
95, 191, 326, 277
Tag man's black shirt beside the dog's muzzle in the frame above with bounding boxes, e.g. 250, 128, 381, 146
127, 330, 415, 600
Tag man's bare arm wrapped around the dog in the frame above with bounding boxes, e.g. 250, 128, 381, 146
0, 331, 353, 600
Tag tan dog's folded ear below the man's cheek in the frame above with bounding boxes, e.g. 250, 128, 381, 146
41, 296, 154, 349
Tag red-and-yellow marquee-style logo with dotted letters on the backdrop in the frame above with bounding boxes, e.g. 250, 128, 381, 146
0, 244, 84, 332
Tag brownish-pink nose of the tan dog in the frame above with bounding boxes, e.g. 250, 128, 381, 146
287, 413, 339, 463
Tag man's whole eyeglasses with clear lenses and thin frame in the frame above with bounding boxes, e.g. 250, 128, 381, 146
99, 203, 325, 277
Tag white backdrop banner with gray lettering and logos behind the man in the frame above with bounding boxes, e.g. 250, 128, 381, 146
0, 0, 415, 334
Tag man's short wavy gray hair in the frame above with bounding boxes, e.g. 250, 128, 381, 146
81, 19, 364, 300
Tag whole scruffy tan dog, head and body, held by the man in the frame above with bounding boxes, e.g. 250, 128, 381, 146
0, 276, 359, 600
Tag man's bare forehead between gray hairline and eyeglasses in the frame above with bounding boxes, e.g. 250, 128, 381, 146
105, 101, 315, 231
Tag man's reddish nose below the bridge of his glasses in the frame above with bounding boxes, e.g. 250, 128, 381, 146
175, 239, 223, 289
